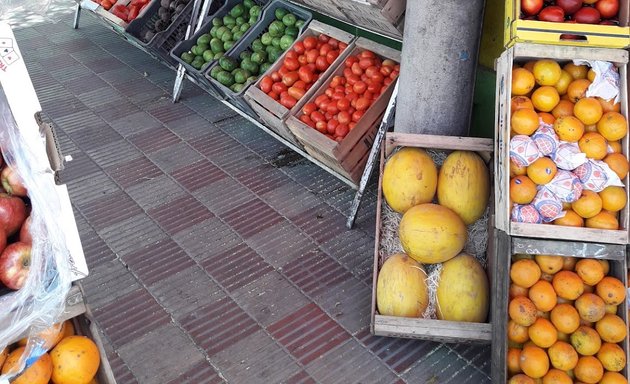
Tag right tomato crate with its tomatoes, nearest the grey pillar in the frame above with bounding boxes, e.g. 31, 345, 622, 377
286, 38, 400, 184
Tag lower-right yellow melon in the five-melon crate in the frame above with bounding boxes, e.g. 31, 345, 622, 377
436, 253, 490, 323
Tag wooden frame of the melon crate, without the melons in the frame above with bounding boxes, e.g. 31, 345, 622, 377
370, 132, 497, 343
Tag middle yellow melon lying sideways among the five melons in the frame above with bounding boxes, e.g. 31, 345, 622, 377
398, 204, 468, 264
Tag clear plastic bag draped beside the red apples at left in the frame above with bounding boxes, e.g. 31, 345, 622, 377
0, 91, 71, 383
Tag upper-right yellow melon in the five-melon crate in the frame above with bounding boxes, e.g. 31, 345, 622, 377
437, 151, 490, 225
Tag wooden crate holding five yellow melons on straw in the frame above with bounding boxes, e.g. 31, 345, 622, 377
371, 132, 495, 343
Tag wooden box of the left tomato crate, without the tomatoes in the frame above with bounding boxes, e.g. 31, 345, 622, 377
245, 20, 355, 147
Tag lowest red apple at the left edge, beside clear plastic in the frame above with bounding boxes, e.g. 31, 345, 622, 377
0, 241, 31, 290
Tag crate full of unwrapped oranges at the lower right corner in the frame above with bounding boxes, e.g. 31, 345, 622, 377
492, 232, 628, 384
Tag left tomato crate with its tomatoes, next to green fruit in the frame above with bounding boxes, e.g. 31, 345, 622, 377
245, 21, 354, 146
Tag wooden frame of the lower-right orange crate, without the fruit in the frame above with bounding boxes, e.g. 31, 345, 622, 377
490, 230, 630, 383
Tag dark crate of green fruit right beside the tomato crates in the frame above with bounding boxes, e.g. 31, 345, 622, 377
205, 0, 312, 112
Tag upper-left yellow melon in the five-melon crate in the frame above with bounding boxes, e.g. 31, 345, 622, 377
383, 147, 438, 213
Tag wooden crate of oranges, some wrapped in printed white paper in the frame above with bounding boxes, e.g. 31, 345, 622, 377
495, 44, 629, 244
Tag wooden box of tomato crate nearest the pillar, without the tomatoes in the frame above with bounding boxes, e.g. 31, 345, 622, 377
286, 38, 400, 185
